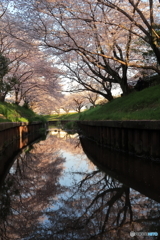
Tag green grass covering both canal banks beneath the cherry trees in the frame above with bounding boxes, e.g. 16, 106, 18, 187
0, 85, 160, 122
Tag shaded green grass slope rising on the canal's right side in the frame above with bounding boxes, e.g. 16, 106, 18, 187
52, 85, 160, 120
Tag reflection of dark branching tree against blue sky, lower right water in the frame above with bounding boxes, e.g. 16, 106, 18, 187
44, 170, 160, 240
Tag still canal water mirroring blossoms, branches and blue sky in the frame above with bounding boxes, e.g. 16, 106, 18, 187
0, 129, 160, 240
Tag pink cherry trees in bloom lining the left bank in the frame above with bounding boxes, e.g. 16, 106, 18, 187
0, 7, 61, 105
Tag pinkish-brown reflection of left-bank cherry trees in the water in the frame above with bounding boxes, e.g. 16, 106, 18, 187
0, 135, 65, 240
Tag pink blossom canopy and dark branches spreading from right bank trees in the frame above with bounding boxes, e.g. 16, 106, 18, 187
3, 0, 160, 100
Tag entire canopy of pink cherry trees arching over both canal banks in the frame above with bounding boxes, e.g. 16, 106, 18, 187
0, 0, 160, 112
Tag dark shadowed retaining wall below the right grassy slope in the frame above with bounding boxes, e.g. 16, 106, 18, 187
77, 120, 160, 159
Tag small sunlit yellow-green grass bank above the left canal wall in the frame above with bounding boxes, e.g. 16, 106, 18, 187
0, 103, 45, 122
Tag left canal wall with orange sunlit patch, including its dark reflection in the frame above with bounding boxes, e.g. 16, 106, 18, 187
0, 122, 47, 183
